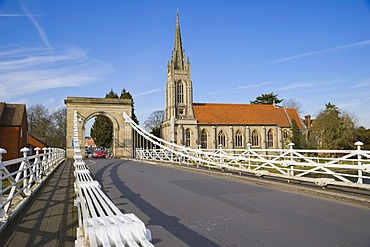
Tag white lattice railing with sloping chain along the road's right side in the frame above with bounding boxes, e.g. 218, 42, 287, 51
123, 113, 370, 190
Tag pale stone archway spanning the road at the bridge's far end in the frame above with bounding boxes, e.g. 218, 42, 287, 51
64, 97, 133, 158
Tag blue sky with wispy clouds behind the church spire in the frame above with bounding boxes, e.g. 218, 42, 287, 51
0, 0, 370, 128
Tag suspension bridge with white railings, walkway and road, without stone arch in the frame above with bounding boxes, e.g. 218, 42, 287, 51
0, 112, 370, 246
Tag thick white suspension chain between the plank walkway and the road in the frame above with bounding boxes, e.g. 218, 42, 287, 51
74, 111, 154, 247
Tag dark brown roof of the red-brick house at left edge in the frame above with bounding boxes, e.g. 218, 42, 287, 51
0, 102, 26, 126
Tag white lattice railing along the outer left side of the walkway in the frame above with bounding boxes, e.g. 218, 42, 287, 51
0, 147, 65, 227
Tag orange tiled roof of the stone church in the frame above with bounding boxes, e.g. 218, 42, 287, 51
193, 103, 303, 129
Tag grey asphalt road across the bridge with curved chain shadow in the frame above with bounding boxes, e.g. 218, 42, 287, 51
86, 159, 370, 247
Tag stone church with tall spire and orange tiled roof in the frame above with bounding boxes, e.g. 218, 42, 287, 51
162, 13, 304, 149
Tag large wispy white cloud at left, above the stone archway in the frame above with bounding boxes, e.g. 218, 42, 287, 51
0, 47, 112, 101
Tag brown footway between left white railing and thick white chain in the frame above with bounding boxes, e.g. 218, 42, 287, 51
0, 161, 78, 247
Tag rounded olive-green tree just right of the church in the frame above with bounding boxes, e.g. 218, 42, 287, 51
312, 103, 355, 150
